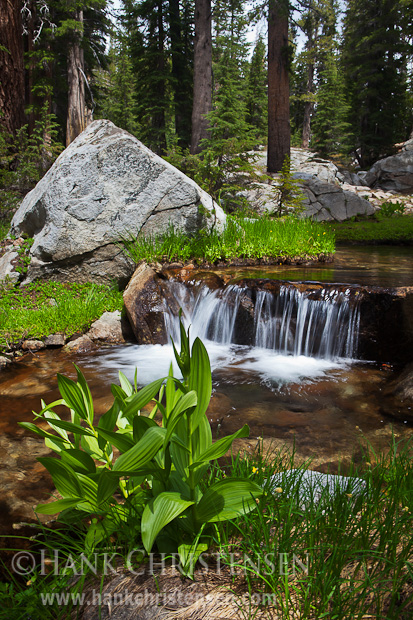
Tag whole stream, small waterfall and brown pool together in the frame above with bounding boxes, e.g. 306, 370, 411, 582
0, 248, 413, 530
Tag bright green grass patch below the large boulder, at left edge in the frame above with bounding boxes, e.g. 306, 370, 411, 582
0, 282, 123, 350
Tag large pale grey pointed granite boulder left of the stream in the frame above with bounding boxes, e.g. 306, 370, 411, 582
11, 120, 225, 283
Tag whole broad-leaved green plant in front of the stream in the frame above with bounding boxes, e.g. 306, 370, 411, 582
21, 323, 262, 576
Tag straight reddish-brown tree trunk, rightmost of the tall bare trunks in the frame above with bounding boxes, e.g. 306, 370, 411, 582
267, 0, 290, 172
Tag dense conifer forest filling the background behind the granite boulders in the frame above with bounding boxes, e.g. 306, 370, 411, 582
0, 0, 413, 219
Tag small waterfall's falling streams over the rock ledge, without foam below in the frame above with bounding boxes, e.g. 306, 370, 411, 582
165, 282, 360, 360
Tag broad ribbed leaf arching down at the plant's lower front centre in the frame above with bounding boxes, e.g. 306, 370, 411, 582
141, 493, 193, 553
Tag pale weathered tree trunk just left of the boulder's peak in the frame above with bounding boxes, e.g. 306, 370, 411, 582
66, 10, 87, 146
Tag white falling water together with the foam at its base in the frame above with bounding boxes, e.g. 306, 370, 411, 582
98, 282, 359, 385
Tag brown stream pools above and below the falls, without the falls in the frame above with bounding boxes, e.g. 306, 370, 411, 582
0, 247, 413, 531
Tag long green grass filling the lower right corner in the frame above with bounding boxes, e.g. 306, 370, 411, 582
217, 438, 413, 620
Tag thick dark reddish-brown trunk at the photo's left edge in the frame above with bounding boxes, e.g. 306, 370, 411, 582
0, 0, 24, 134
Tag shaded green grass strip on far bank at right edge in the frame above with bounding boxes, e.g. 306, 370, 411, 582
328, 215, 413, 244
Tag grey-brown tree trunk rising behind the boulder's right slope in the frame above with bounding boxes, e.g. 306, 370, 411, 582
191, 0, 212, 153
